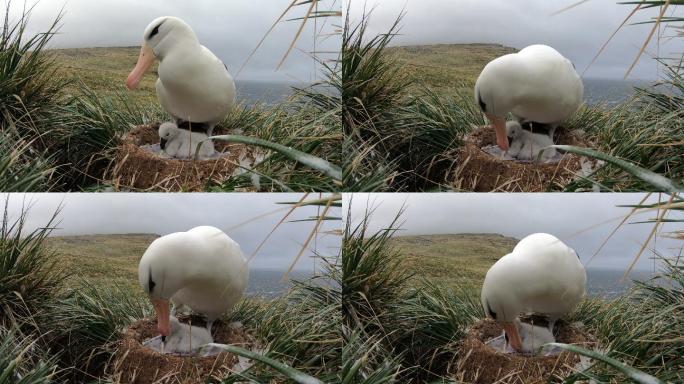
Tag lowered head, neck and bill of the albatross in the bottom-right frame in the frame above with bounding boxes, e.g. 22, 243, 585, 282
480, 255, 522, 351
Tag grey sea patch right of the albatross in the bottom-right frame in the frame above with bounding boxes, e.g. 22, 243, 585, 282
587, 268, 653, 298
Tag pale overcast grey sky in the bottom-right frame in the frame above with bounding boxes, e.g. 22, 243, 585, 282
344, 193, 684, 270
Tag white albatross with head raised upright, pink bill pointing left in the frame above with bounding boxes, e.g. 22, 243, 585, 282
126, 16, 235, 136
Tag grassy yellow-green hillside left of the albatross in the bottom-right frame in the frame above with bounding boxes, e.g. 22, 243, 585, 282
392, 234, 518, 289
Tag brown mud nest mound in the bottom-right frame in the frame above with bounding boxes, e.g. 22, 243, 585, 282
458, 319, 595, 384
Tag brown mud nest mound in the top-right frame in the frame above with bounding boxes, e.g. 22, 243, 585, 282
454, 127, 587, 192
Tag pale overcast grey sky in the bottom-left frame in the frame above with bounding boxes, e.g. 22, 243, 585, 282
0, 193, 341, 271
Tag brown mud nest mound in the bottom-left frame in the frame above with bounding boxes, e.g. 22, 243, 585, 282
111, 319, 256, 384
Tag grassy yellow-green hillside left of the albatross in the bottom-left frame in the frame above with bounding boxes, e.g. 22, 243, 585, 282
48, 234, 159, 291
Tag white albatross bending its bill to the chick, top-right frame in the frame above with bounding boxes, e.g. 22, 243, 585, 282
475, 45, 584, 150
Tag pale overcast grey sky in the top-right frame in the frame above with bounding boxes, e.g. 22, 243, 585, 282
350, 0, 684, 80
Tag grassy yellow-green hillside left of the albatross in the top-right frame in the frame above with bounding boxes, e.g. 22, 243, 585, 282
387, 44, 517, 90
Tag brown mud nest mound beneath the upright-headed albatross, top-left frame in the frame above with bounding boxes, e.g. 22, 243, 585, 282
108, 124, 251, 192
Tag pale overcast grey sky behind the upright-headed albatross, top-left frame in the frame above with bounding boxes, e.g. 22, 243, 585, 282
0, 0, 341, 81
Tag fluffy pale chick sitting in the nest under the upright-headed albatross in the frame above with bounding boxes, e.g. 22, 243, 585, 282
159, 123, 215, 160
